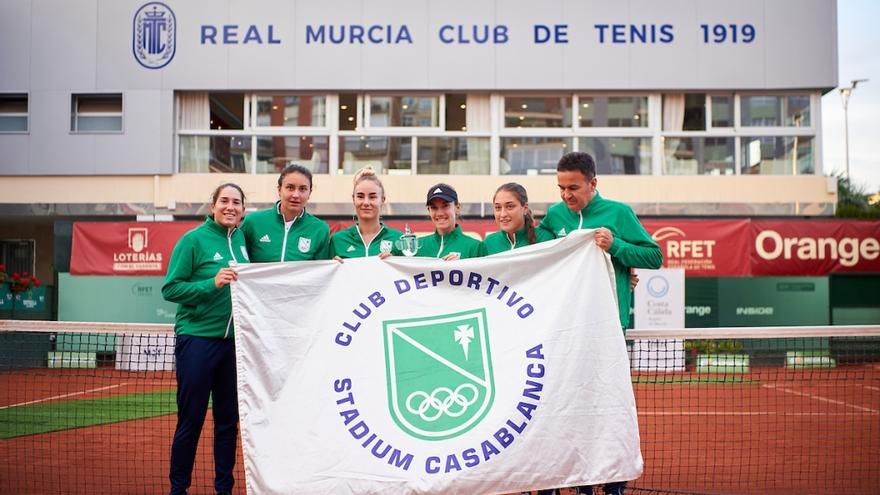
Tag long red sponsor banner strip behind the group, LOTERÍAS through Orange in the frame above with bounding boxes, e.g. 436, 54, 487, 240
70, 219, 880, 277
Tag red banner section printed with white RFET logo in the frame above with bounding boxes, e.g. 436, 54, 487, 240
642, 219, 750, 277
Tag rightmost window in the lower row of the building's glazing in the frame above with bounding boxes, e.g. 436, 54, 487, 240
740, 136, 815, 175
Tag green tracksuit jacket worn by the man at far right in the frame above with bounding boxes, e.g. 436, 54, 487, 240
538, 191, 663, 330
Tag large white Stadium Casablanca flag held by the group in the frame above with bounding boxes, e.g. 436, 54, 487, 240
232, 231, 642, 494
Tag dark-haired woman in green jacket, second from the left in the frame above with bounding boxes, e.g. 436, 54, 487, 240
241, 164, 330, 262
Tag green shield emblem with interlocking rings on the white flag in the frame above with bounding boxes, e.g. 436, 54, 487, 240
383, 309, 495, 440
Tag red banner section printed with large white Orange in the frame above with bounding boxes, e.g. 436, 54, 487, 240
749, 220, 880, 275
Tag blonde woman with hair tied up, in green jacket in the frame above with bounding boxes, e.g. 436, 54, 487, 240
330, 167, 403, 261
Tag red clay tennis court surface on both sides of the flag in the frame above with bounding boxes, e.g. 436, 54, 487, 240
0, 364, 880, 495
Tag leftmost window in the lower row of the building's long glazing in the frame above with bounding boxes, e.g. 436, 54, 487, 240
178, 136, 251, 174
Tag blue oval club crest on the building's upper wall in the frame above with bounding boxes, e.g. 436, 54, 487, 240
131, 2, 177, 69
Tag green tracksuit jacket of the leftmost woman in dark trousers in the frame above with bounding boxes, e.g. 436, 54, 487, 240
162, 218, 248, 339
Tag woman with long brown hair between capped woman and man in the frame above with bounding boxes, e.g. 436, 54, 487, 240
483, 182, 553, 255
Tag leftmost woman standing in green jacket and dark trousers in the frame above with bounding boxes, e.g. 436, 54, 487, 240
162, 184, 248, 495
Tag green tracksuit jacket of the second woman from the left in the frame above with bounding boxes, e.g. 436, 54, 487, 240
241, 201, 330, 263
